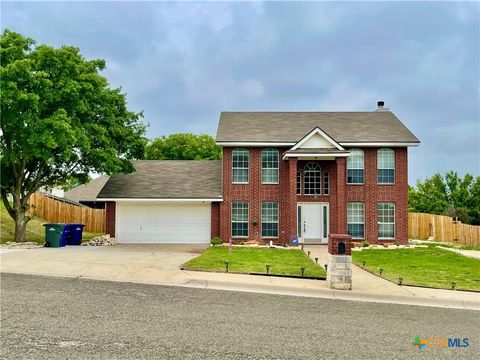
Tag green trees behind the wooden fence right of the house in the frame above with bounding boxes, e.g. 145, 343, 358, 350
408, 171, 480, 225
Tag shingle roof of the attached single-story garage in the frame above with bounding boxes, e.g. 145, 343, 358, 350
97, 160, 222, 200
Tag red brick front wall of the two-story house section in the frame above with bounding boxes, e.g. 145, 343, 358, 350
218, 147, 408, 244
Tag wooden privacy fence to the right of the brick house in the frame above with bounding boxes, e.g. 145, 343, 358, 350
408, 213, 480, 246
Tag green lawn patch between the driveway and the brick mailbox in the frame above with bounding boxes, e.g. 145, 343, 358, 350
183, 246, 325, 277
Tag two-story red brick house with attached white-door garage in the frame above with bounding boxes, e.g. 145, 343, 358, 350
99, 102, 419, 244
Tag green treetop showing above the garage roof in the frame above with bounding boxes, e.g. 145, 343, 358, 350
145, 134, 222, 160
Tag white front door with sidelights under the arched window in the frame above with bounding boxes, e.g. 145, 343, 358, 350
297, 203, 329, 244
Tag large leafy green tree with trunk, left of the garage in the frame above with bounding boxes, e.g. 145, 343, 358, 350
0, 30, 145, 241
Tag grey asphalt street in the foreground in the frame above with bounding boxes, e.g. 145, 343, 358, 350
0, 274, 480, 359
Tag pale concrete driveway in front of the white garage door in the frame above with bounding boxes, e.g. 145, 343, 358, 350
0, 245, 207, 284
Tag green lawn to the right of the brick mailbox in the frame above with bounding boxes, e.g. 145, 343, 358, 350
352, 245, 480, 291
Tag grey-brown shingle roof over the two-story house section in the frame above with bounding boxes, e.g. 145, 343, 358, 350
216, 111, 420, 143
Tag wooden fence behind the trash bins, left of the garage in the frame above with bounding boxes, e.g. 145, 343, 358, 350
28, 192, 105, 233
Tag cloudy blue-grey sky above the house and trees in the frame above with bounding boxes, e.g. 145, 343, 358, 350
1, 1, 480, 184
